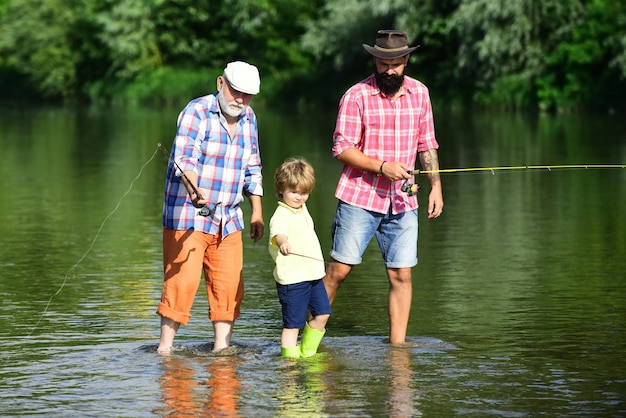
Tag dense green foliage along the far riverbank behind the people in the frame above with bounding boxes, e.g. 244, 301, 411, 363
0, 0, 626, 110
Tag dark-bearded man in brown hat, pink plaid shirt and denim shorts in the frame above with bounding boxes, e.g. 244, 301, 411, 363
324, 30, 443, 344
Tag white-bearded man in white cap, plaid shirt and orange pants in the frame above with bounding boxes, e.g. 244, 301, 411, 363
156, 61, 264, 354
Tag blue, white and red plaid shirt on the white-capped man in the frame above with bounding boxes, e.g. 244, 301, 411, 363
163, 93, 263, 237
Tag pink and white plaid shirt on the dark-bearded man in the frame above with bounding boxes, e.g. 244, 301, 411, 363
332, 74, 439, 214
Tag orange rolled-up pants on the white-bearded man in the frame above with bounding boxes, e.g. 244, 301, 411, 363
156, 229, 243, 325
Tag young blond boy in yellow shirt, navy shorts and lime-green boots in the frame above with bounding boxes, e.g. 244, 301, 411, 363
269, 158, 331, 358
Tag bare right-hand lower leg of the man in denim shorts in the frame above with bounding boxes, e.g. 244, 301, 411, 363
387, 268, 413, 344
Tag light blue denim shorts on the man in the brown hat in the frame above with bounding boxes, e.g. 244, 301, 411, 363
330, 200, 417, 268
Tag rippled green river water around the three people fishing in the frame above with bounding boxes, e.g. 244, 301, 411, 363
0, 103, 626, 417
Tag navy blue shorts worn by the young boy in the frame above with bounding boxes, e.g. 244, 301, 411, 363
276, 279, 331, 328
